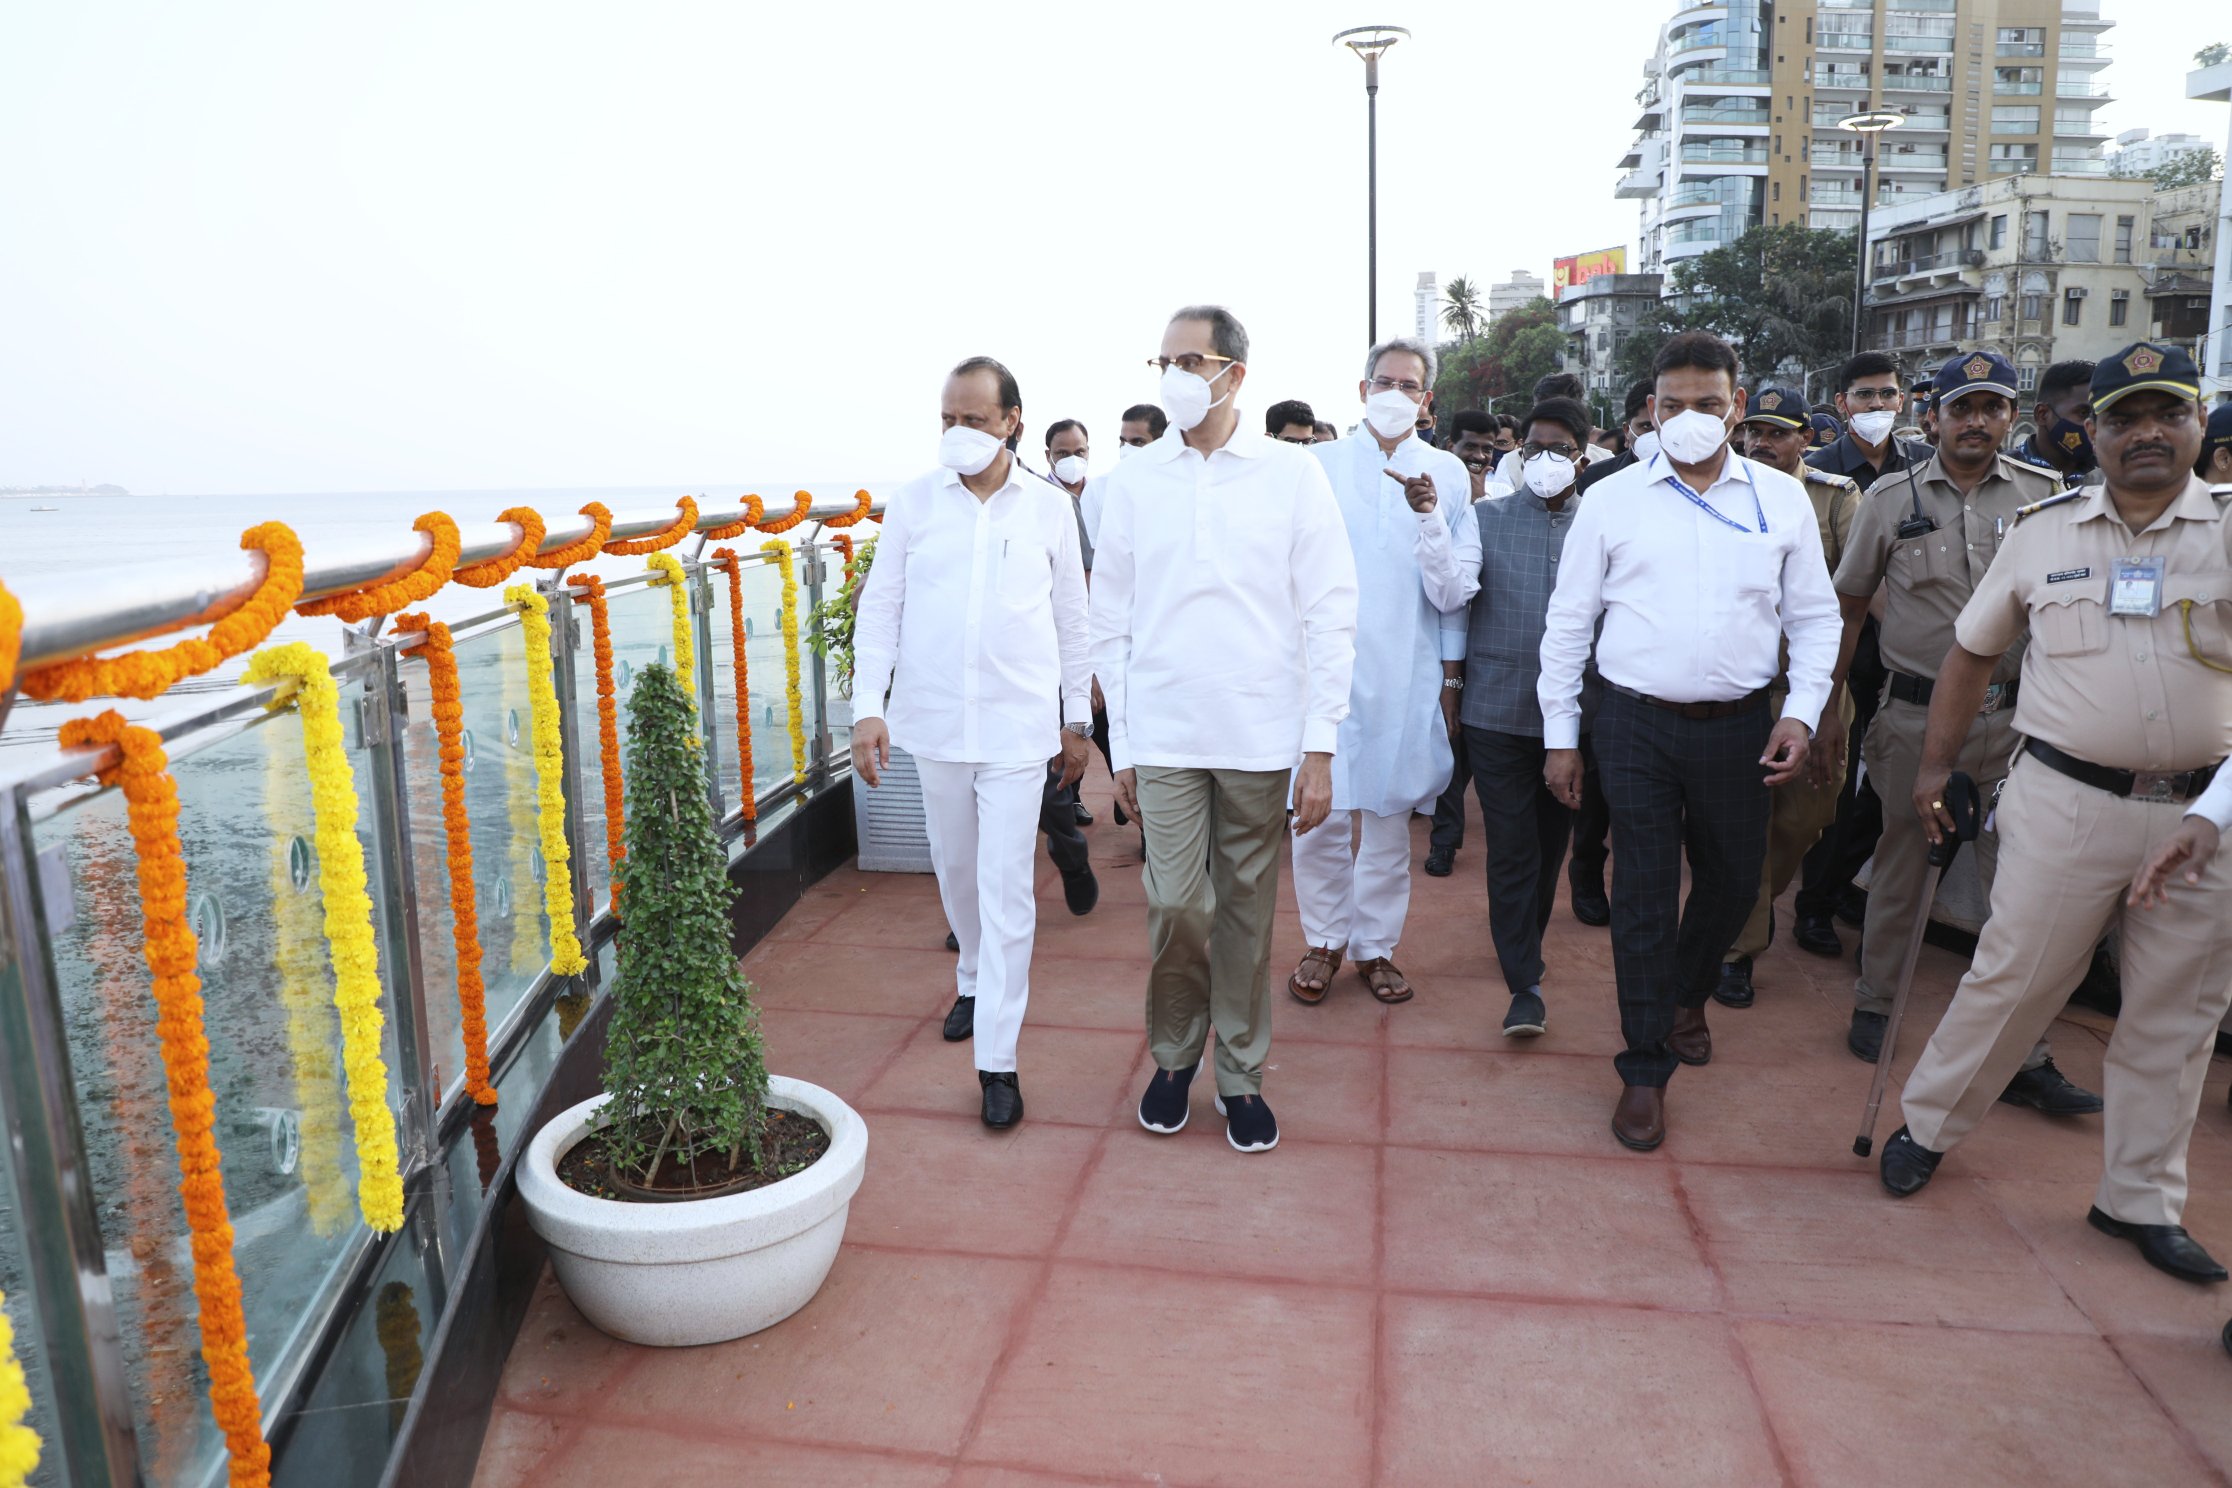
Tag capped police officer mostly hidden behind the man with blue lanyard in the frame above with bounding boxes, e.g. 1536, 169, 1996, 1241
1712, 388, 1859, 1008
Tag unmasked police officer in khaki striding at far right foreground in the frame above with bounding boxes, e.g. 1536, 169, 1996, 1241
1882, 341, 2232, 1281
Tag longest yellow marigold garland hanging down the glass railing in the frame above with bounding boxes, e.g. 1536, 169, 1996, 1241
241, 640, 404, 1234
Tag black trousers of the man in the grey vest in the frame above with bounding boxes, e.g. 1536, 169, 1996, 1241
1464, 727, 1591, 997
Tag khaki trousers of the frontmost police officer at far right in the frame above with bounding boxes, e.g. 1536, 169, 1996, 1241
1902, 759, 2232, 1225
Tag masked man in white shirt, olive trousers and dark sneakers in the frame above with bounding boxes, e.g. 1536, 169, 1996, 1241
1091, 306, 1357, 1151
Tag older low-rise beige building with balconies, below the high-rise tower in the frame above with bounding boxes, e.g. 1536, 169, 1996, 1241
1864, 176, 2221, 419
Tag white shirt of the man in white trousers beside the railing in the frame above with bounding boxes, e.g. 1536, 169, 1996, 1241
853, 460, 1094, 765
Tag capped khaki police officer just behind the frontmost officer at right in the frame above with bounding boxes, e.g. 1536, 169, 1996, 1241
1824, 352, 2100, 1115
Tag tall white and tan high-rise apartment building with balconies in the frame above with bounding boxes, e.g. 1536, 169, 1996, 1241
1618, 0, 2114, 272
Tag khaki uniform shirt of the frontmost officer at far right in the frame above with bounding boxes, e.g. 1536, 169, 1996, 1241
1957, 477, 2232, 770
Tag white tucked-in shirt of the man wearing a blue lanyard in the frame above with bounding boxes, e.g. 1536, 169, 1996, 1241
1536, 451, 1844, 750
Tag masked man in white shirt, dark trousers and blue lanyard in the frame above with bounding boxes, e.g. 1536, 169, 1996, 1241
1536, 330, 1844, 1151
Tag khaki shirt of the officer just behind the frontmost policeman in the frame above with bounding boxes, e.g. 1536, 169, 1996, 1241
1837, 455, 2060, 683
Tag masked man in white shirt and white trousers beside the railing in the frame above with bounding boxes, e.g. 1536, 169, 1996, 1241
853, 357, 1094, 1129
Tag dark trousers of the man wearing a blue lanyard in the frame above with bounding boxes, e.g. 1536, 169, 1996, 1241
1594, 689, 1774, 1086
